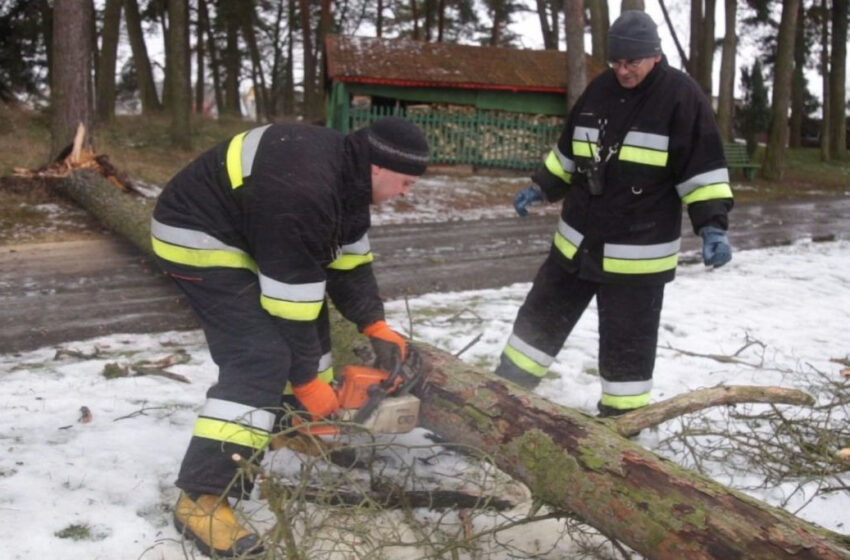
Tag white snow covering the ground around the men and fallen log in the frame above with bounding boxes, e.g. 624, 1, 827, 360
0, 199, 850, 560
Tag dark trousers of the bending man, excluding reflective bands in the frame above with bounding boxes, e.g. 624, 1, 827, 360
159, 259, 291, 497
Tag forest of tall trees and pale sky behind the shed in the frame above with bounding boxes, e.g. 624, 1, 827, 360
0, 0, 848, 184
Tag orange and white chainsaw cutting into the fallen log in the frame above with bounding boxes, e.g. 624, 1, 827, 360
294, 345, 424, 436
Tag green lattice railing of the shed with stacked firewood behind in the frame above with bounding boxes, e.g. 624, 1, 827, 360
349, 106, 563, 170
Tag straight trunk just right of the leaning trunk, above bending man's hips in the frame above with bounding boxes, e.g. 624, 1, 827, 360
165, 0, 192, 149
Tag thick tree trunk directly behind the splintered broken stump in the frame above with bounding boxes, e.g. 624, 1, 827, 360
50, 0, 94, 160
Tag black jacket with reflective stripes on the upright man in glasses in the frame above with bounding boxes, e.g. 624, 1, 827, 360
533, 59, 733, 284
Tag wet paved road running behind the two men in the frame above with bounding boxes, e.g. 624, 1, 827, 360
0, 197, 850, 353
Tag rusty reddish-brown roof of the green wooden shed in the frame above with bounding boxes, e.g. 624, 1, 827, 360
325, 35, 605, 93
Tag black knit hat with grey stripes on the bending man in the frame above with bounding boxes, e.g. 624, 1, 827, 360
368, 117, 428, 175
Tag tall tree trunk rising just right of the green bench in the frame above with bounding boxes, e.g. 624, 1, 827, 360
761, 0, 800, 181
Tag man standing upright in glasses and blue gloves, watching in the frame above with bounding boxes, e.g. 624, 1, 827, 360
496, 10, 733, 416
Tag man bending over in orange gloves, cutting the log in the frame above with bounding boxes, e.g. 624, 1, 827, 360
151, 117, 428, 556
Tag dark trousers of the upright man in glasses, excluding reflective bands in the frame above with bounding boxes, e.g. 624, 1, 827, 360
504, 252, 664, 390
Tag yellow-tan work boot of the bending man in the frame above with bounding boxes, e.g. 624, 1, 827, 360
174, 492, 263, 558
